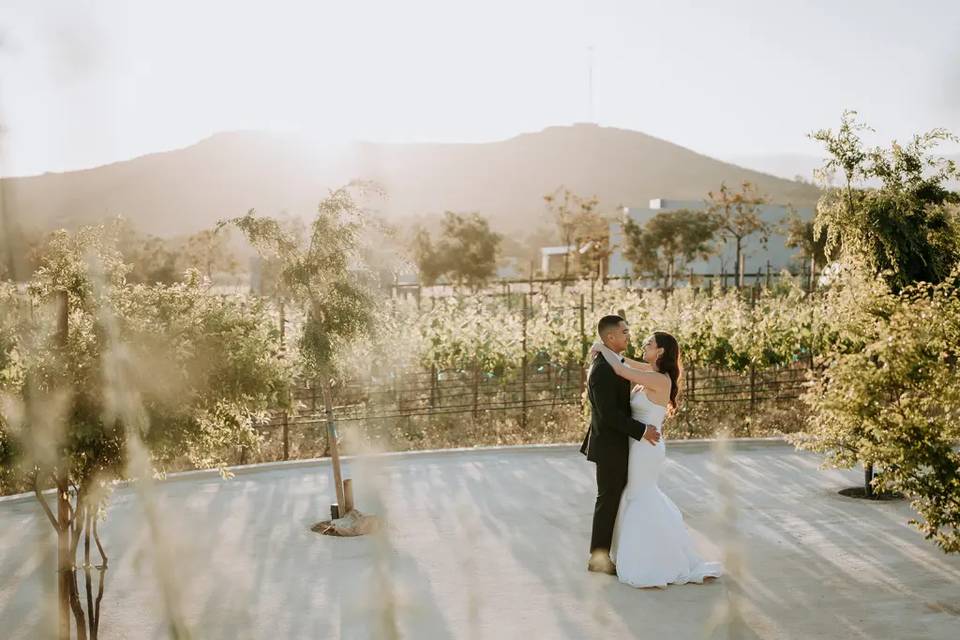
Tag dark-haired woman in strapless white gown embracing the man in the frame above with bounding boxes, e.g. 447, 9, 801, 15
590, 331, 723, 587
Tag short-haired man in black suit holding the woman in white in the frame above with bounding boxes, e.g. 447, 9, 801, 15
580, 316, 660, 574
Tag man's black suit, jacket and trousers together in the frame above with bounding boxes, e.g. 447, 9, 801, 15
580, 354, 646, 553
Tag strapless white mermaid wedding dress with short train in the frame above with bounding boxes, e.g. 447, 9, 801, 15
610, 391, 723, 587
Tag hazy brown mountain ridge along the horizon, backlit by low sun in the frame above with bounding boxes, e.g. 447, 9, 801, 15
0, 124, 819, 236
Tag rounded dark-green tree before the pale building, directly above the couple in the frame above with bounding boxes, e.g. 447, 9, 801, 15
623, 209, 717, 283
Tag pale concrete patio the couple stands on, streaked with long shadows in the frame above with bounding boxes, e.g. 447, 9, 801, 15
0, 442, 960, 640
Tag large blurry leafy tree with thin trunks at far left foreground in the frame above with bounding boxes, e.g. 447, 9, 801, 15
0, 227, 286, 638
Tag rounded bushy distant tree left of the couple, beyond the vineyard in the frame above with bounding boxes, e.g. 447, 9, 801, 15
414, 211, 501, 290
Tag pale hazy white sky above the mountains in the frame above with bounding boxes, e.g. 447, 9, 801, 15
0, 0, 960, 175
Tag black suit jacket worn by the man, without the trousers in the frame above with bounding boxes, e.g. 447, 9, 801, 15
580, 354, 647, 468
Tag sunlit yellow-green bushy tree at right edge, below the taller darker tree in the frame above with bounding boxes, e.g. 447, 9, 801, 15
795, 274, 960, 552
